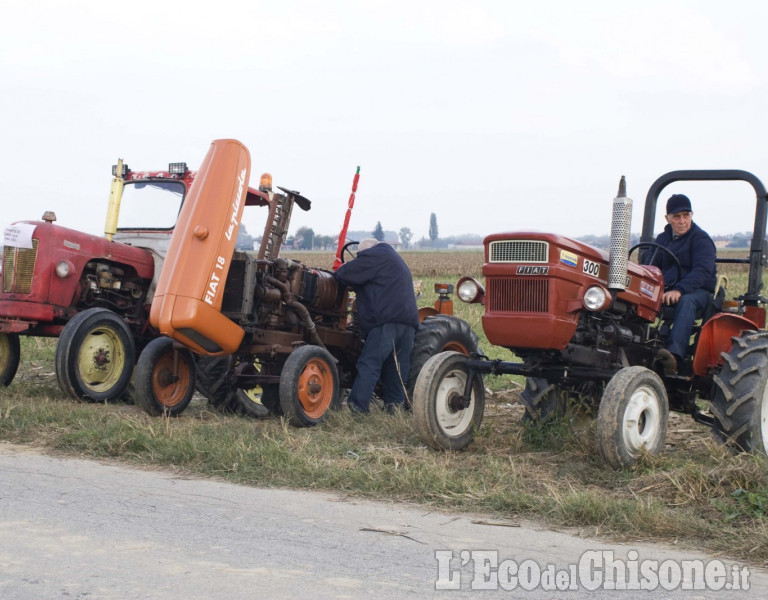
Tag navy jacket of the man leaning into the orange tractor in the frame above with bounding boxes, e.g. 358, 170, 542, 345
336, 243, 419, 336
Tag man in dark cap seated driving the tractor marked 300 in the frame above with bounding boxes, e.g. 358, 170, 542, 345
650, 194, 717, 375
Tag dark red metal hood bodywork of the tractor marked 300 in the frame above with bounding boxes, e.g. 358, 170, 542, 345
482, 231, 664, 350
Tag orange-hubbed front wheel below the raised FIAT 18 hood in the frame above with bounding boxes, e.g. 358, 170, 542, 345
134, 337, 195, 417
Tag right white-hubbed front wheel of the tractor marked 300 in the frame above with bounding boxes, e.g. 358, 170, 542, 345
597, 367, 669, 469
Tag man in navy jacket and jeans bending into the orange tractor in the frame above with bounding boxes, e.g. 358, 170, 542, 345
336, 238, 419, 413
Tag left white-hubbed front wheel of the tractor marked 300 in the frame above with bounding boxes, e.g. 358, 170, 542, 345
413, 352, 485, 450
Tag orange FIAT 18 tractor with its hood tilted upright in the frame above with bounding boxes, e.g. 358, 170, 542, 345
134, 140, 478, 426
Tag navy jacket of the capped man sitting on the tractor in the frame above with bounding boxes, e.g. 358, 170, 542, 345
646, 223, 717, 294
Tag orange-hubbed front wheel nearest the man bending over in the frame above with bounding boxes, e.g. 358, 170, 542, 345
279, 346, 340, 427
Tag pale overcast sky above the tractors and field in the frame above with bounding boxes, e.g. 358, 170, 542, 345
0, 0, 768, 240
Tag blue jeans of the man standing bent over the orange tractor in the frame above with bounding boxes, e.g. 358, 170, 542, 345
347, 323, 416, 412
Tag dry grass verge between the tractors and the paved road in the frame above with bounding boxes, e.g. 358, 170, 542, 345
0, 344, 768, 564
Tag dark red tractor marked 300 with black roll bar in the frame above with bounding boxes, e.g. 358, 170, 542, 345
413, 170, 768, 468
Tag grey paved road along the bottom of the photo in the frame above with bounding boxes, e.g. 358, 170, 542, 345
0, 443, 768, 600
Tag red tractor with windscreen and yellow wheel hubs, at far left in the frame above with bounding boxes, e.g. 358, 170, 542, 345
0, 161, 265, 401
